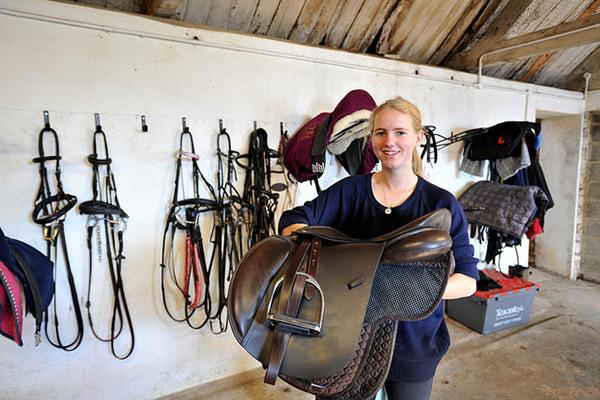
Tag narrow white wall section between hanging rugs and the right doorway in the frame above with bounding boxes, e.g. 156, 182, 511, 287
535, 116, 582, 279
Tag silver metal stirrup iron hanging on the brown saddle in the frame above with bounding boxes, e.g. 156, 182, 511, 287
267, 272, 325, 336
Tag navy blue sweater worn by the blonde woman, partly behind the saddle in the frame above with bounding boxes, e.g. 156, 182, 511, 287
279, 175, 479, 382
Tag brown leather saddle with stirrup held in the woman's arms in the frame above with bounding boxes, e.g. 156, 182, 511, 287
229, 209, 454, 399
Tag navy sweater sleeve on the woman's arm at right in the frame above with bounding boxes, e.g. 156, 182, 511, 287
450, 196, 479, 280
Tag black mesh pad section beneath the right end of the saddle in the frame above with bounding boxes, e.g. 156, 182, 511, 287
365, 253, 452, 323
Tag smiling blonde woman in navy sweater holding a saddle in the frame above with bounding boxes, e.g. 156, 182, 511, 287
279, 97, 478, 400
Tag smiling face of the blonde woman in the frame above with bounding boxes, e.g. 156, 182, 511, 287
371, 107, 423, 170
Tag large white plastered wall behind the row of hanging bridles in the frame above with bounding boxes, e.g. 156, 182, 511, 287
0, 0, 583, 399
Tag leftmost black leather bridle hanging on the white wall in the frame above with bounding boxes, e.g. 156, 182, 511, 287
32, 111, 83, 351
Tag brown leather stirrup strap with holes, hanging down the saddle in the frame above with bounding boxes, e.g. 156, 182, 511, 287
264, 238, 323, 385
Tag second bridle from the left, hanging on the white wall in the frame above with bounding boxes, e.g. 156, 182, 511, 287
79, 114, 135, 360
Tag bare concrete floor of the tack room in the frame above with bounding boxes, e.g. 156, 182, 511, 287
190, 270, 600, 400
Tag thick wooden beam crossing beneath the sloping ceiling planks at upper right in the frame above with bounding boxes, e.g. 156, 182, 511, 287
484, 14, 600, 65
